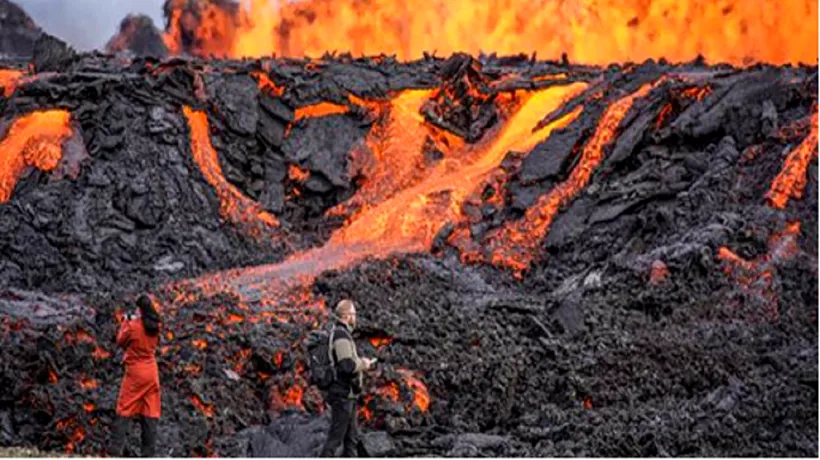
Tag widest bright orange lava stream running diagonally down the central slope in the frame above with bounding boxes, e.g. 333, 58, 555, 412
186, 82, 587, 301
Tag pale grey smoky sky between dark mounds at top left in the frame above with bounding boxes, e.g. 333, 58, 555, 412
12, 0, 165, 51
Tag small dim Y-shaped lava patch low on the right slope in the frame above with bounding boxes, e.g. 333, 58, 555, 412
717, 222, 800, 322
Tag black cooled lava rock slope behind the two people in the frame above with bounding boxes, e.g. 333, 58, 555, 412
0, 41, 818, 456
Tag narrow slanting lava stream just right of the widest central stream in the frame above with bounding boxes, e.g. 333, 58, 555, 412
489, 83, 655, 275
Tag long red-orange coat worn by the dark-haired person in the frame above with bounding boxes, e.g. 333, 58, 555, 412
117, 318, 161, 418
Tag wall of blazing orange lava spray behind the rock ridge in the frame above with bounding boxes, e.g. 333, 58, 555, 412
160, 0, 818, 65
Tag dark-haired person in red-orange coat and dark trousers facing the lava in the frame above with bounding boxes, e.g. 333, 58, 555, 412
111, 295, 160, 457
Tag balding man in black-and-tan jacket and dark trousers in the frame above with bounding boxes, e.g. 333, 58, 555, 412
322, 300, 376, 457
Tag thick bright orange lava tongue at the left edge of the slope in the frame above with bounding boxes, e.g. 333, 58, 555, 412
0, 110, 72, 203
